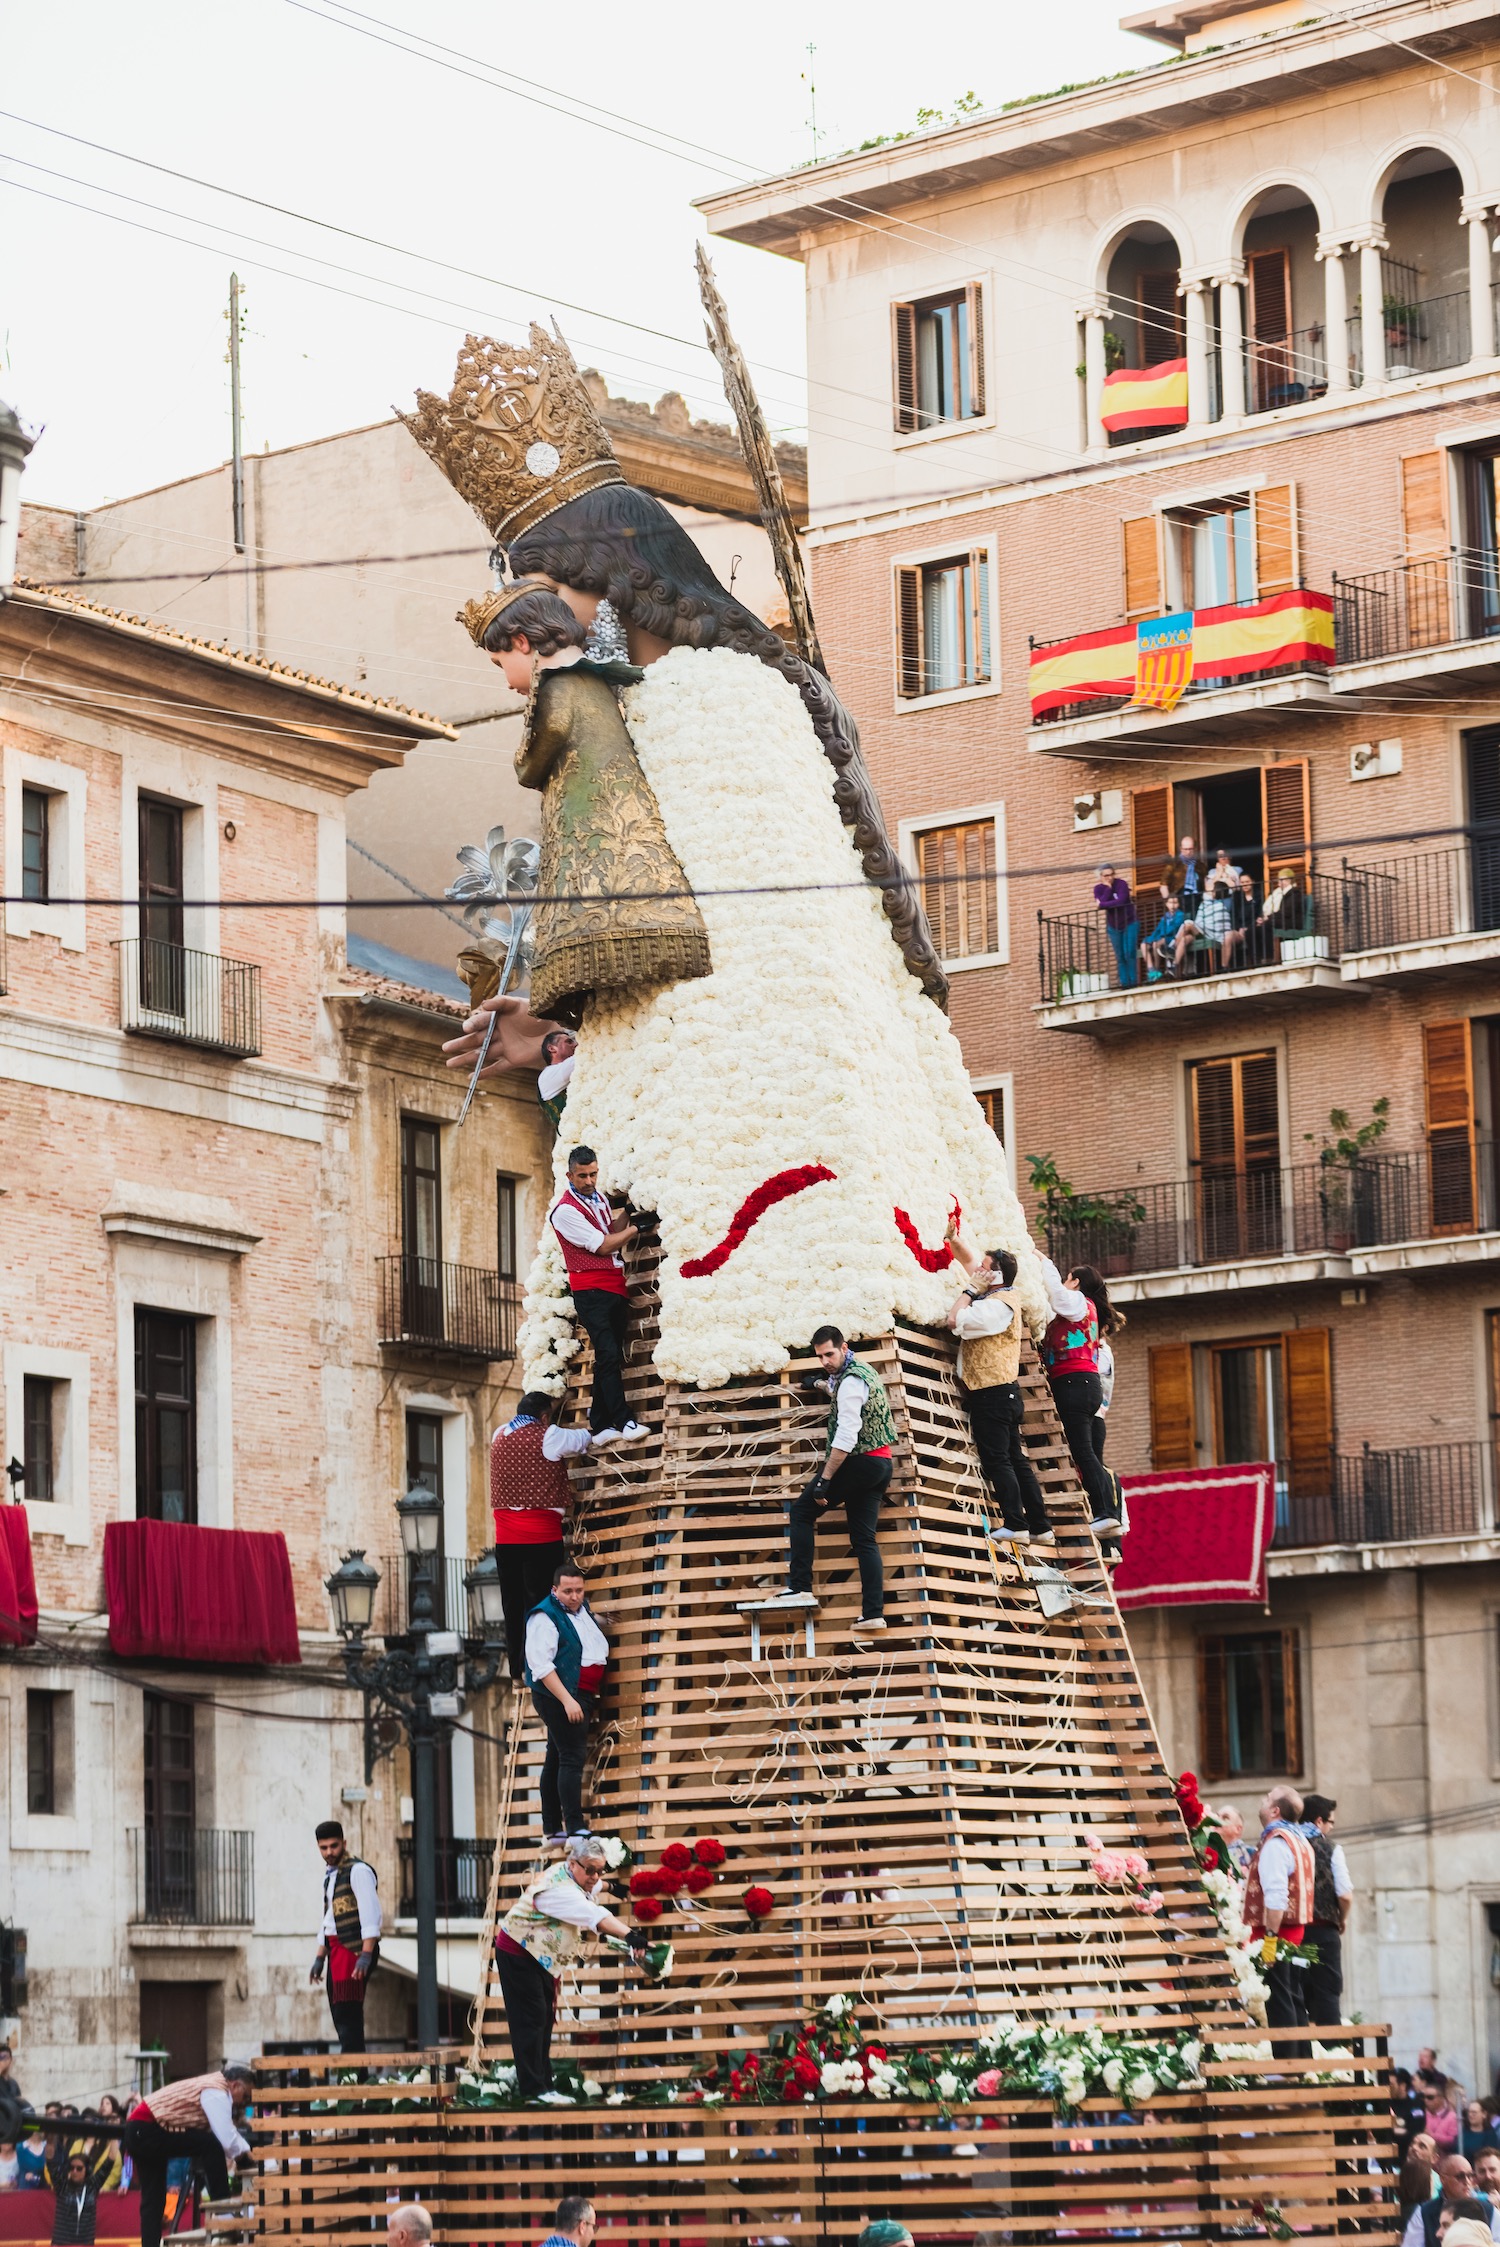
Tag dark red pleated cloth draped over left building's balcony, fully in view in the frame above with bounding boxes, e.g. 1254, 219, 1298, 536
103, 1521, 301, 1663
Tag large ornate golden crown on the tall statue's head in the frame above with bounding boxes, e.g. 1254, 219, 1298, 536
400, 321, 624, 546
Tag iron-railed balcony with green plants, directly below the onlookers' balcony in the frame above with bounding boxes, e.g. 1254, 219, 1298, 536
1040, 1128, 1500, 1303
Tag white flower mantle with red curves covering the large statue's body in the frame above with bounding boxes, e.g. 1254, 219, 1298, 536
521, 647, 1046, 1395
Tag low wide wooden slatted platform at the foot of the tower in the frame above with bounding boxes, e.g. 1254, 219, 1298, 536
256, 2027, 1397, 2247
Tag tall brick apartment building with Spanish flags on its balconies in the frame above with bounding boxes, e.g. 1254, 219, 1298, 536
703, 0, 1500, 2090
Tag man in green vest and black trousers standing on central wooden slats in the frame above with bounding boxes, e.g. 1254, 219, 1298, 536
766, 1326, 896, 1638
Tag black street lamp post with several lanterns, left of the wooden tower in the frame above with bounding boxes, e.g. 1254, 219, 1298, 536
326, 1485, 505, 2052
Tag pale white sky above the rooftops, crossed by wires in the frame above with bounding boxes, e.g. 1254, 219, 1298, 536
0, 0, 1165, 508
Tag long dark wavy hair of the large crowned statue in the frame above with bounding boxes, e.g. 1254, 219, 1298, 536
510, 483, 948, 1004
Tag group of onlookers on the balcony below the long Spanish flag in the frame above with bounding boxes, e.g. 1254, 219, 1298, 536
1094, 836, 1311, 991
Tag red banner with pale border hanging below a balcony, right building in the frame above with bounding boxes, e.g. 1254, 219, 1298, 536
1114, 1463, 1275, 1609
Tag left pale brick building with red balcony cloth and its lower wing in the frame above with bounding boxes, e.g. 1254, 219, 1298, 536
0, 586, 548, 2101
